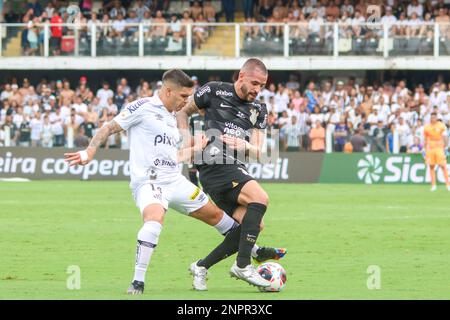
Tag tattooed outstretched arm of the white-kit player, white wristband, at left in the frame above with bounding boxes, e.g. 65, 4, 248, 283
64, 120, 123, 167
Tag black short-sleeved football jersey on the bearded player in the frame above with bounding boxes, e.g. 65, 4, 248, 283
194, 82, 267, 164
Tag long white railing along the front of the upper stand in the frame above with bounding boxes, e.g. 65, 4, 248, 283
0, 21, 450, 58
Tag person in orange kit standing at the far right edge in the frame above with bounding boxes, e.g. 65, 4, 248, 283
424, 112, 450, 191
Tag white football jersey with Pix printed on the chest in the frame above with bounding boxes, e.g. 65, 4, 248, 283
114, 95, 180, 190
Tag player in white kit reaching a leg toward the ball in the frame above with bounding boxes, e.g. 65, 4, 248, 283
64, 69, 270, 294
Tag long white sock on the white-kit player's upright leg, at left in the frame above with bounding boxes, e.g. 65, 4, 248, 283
134, 221, 162, 282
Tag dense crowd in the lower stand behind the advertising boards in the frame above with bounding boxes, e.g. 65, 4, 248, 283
0, 74, 450, 153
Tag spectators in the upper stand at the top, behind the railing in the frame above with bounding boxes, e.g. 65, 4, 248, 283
0, 0, 450, 55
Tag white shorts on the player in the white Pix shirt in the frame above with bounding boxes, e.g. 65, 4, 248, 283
133, 174, 209, 214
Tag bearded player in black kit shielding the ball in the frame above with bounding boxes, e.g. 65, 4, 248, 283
177, 59, 286, 289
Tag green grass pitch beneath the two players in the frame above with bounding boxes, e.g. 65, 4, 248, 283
0, 181, 450, 299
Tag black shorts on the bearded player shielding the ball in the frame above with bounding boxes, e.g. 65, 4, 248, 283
198, 164, 254, 216
